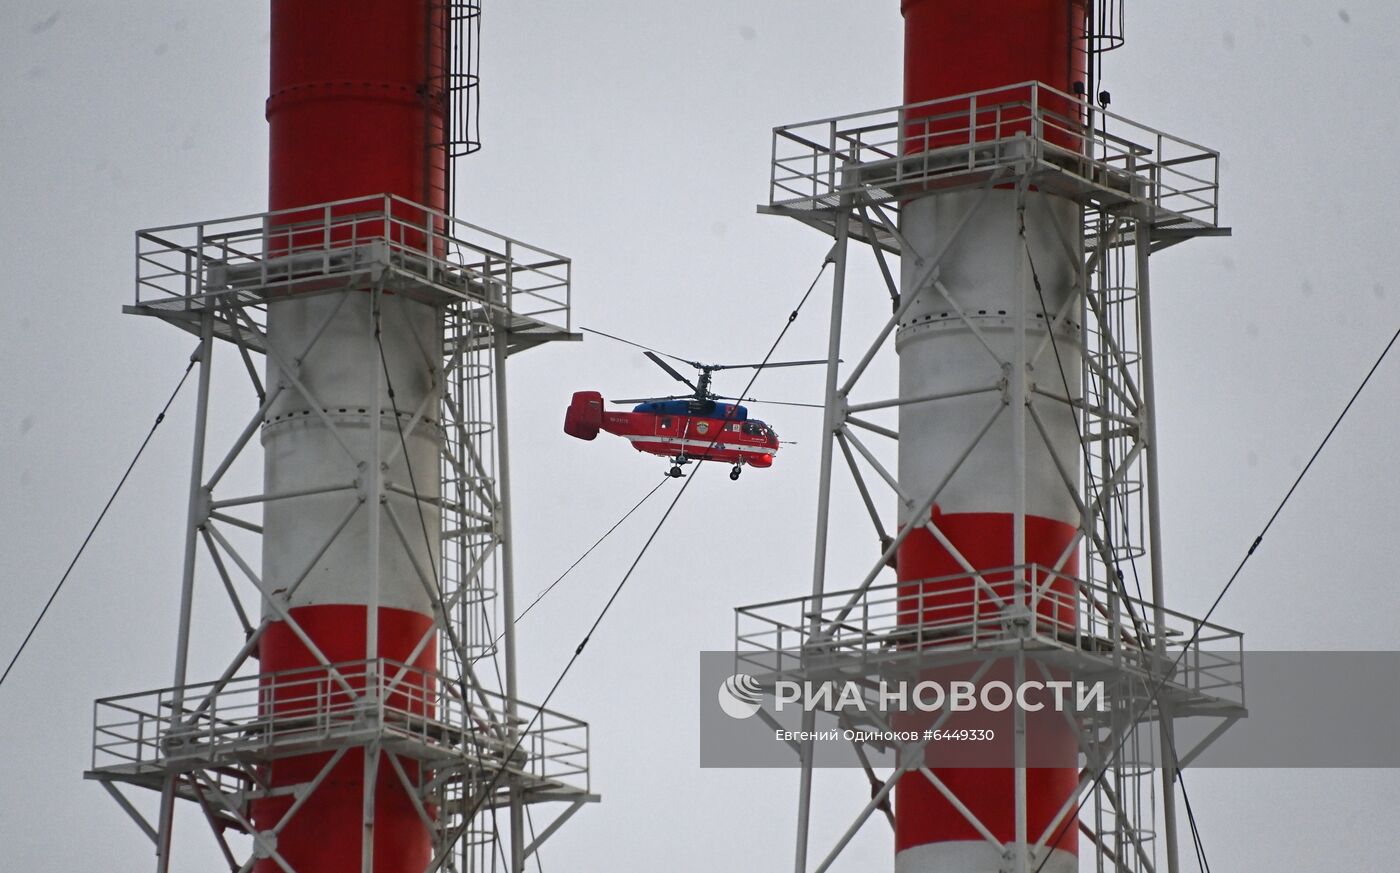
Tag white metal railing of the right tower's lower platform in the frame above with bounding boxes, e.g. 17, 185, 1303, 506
735, 564, 1243, 704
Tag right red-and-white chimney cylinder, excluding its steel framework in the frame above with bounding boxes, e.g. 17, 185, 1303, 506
895, 0, 1088, 873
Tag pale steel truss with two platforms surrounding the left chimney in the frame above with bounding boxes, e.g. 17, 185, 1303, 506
85, 196, 598, 873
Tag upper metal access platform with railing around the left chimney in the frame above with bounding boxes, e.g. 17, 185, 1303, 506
125, 194, 578, 353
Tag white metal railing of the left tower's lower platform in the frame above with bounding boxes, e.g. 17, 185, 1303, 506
92, 659, 588, 790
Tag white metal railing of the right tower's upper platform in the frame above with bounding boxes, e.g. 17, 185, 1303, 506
769, 83, 1219, 227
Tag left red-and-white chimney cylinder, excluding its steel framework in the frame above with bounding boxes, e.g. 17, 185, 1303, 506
253, 0, 447, 873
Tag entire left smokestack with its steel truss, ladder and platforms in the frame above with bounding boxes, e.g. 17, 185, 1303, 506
90, 0, 596, 873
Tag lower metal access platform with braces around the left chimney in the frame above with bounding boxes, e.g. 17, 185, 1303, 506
84, 659, 598, 861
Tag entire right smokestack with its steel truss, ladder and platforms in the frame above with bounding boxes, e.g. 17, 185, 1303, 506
736, 0, 1243, 873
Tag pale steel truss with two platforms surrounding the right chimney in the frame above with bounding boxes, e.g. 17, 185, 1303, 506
736, 90, 1245, 873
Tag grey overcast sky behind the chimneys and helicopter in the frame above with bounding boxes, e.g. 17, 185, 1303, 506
0, 0, 1400, 873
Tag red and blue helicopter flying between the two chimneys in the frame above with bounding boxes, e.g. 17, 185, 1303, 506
564, 329, 826, 480
